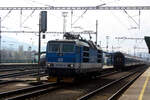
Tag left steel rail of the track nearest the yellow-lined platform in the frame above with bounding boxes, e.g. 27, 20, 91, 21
77, 67, 145, 100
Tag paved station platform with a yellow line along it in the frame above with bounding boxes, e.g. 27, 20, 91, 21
118, 67, 150, 100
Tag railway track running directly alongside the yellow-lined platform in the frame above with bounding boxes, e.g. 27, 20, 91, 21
77, 66, 145, 100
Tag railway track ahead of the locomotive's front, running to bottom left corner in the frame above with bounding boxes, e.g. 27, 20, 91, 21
0, 83, 61, 100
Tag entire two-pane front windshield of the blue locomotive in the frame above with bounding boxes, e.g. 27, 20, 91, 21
48, 43, 74, 53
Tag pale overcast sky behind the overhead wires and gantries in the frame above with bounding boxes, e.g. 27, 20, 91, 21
0, 0, 150, 53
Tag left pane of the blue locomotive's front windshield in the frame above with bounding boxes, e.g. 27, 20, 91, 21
48, 43, 60, 52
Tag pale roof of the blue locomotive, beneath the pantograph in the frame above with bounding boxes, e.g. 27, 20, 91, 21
48, 39, 101, 50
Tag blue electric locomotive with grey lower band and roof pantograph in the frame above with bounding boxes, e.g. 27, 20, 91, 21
46, 33, 102, 81
